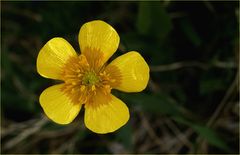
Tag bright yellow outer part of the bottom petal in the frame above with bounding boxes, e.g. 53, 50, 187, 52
84, 95, 129, 134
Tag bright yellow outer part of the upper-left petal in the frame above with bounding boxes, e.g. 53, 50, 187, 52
37, 38, 77, 80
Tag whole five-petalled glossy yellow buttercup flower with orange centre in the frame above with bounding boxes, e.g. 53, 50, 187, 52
37, 20, 149, 134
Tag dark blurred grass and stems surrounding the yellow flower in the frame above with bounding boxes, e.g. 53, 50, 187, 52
1, 0, 239, 154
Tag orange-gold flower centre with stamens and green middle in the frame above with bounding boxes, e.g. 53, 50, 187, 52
62, 49, 121, 105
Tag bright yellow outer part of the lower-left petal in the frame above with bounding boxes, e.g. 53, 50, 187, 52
39, 84, 81, 124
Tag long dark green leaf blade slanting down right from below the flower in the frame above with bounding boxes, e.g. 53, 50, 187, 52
121, 94, 229, 151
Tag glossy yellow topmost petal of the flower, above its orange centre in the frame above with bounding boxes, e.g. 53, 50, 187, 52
78, 20, 120, 65
